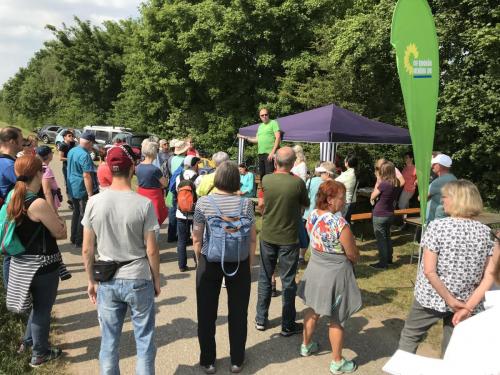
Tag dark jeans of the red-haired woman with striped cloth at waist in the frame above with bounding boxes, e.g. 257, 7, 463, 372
23, 269, 59, 357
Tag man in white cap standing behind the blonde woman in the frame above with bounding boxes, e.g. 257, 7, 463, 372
426, 154, 457, 224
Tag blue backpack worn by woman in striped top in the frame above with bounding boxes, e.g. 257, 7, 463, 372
205, 195, 252, 276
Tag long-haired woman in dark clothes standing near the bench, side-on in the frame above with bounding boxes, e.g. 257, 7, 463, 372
370, 161, 399, 269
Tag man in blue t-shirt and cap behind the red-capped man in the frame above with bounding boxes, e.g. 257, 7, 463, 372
68, 131, 99, 247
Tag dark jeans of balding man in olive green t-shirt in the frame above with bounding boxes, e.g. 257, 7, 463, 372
255, 240, 299, 329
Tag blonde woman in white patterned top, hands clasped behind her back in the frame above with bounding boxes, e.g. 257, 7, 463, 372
399, 180, 500, 353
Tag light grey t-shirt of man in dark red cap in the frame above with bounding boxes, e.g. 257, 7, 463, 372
82, 189, 160, 280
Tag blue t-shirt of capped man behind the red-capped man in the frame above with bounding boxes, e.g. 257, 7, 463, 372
68, 146, 98, 199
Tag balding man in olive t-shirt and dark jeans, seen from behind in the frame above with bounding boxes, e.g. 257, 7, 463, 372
255, 147, 309, 337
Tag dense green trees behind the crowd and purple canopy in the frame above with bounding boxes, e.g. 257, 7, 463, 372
0, 0, 500, 207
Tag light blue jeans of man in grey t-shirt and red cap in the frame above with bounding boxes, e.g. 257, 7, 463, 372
97, 279, 156, 375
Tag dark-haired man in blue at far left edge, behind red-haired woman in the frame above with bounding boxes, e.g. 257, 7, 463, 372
0, 126, 23, 289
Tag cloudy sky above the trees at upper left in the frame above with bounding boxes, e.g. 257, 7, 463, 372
0, 0, 143, 87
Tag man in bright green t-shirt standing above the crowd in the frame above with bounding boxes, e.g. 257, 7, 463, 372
238, 108, 281, 181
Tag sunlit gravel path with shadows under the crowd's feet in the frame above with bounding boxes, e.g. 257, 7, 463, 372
51, 156, 436, 375
